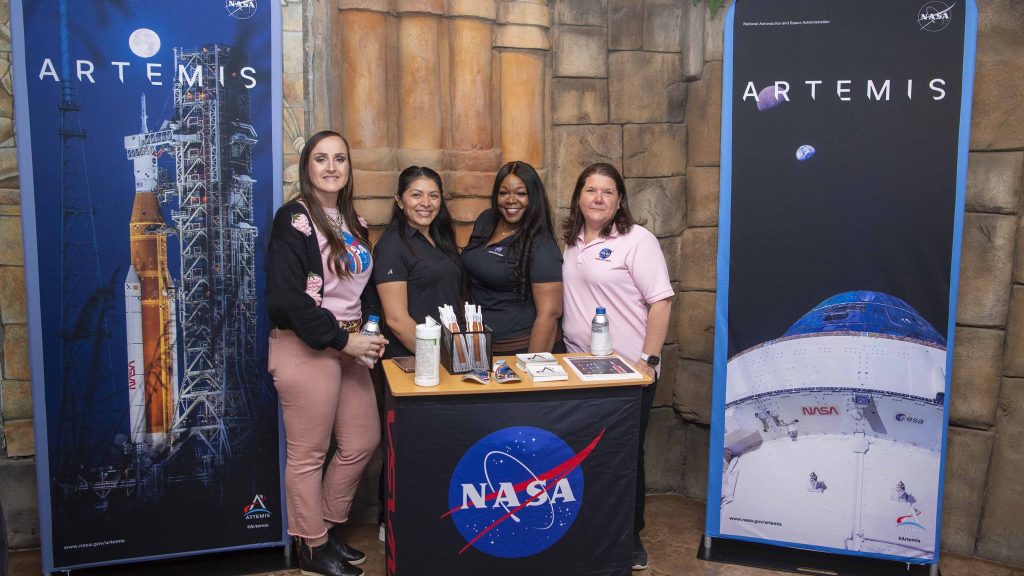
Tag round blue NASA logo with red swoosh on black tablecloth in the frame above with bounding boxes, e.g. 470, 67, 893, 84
441, 426, 604, 558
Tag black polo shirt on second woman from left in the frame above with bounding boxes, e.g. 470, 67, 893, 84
374, 227, 462, 358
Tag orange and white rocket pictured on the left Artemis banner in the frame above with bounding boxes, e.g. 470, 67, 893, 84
125, 95, 178, 447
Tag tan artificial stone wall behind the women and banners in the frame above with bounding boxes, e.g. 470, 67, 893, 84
0, 0, 1024, 566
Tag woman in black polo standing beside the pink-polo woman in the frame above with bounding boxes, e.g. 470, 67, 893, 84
462, 162, 562, 355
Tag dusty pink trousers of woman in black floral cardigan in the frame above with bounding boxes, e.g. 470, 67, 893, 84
269, 329, 380, 539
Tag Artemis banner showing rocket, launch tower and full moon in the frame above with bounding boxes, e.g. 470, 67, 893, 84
10, 0, 285, 572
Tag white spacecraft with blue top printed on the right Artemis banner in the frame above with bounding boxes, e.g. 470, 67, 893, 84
721, 291, 946, 559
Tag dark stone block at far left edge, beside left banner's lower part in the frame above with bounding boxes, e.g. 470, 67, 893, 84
0, 459, 41, 545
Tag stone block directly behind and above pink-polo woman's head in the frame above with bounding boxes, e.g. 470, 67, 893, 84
548, 126, 623, 207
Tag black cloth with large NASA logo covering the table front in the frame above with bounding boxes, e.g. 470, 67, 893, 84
384, 386, 641, 576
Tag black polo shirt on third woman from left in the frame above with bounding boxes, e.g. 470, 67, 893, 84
460, 210, 562, 340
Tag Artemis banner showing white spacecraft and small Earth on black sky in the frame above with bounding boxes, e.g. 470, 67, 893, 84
706, 0, 977, 564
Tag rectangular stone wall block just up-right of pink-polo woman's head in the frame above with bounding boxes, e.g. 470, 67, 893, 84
623, 124, 686, 178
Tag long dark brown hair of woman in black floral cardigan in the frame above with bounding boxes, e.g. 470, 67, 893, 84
298, 130, 370, 277
